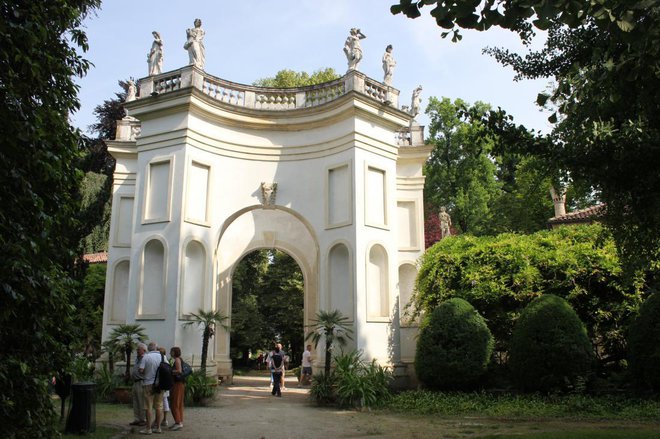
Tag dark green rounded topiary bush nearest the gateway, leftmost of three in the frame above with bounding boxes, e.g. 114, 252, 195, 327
415, 298, 494, 389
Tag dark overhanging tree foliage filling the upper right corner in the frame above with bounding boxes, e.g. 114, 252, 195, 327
391, 0, 660, 272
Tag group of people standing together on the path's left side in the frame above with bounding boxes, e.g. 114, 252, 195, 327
130, 341, 186, 434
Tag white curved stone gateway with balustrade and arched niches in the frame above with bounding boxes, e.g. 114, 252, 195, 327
103, 66, 430, 384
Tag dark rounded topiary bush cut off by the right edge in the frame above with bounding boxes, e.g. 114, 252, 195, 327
628, 293, 660, 390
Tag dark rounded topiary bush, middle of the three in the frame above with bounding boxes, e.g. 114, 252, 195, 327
509, 294, 594, 392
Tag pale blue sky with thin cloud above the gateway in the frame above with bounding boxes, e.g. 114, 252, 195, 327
72, 0, 550, 136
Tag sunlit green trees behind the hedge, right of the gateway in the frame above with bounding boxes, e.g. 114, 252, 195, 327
424, 96, 590, 242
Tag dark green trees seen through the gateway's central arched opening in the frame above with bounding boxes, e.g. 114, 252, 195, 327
230, 249, 305, 375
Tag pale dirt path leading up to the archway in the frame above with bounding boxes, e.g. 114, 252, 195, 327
112, 376, 658, 439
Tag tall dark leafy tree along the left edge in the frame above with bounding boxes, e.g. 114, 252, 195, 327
0, 0, 100, 438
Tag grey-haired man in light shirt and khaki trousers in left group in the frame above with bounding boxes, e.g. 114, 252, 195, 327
138, 341, 163, 434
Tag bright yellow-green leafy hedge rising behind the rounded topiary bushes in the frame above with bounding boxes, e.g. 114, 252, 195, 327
414, 224, 645, 361
